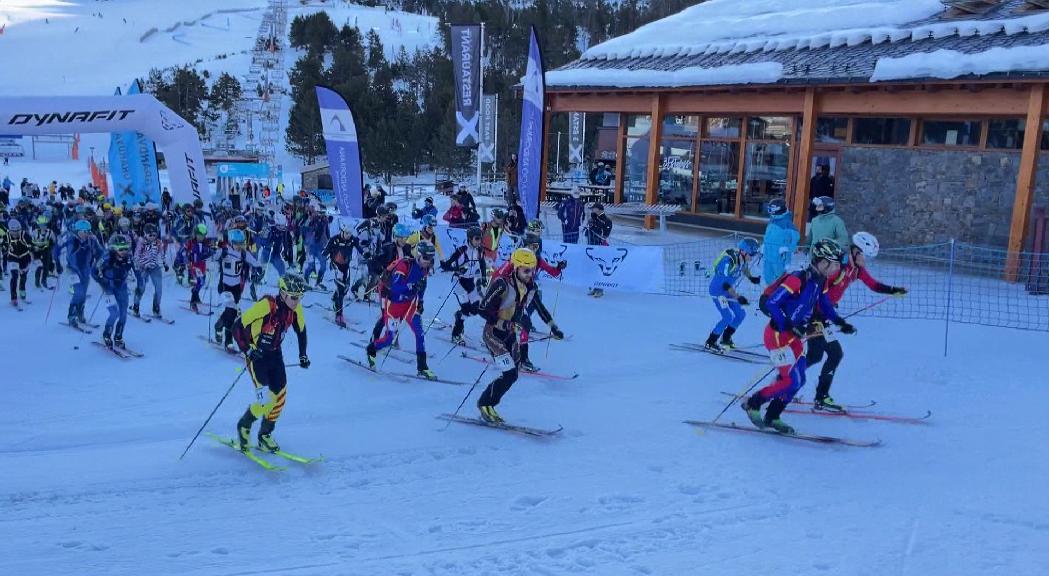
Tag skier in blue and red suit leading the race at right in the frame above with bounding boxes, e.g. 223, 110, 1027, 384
742, 239, 856, 434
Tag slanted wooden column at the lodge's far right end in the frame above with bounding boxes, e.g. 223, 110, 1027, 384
1005, 84, 1046, 282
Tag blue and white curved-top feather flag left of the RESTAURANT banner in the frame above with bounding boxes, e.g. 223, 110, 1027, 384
317, 86, 364, 218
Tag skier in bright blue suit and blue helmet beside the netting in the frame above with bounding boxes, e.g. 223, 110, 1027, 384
706, 238, 761, 353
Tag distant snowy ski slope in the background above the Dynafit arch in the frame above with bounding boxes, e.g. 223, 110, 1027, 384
0, 0, 436, 95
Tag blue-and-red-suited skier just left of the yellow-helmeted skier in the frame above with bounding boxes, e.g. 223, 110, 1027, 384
367, 240, 436, 380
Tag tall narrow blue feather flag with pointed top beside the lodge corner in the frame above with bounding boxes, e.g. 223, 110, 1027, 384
517, 26, 547, 219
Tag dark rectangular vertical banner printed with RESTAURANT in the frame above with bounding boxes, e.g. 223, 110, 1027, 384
452, 24, 480, 147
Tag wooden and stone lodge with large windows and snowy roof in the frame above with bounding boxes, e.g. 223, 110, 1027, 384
543, 0, 1049, 257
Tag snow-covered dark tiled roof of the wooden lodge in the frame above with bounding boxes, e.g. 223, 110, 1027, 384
547, 0, 1049, 90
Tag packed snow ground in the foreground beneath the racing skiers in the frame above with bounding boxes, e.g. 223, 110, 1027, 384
0, 257, 1049, 576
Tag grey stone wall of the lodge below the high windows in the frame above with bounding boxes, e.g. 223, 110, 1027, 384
835, 148, 1049, 248
